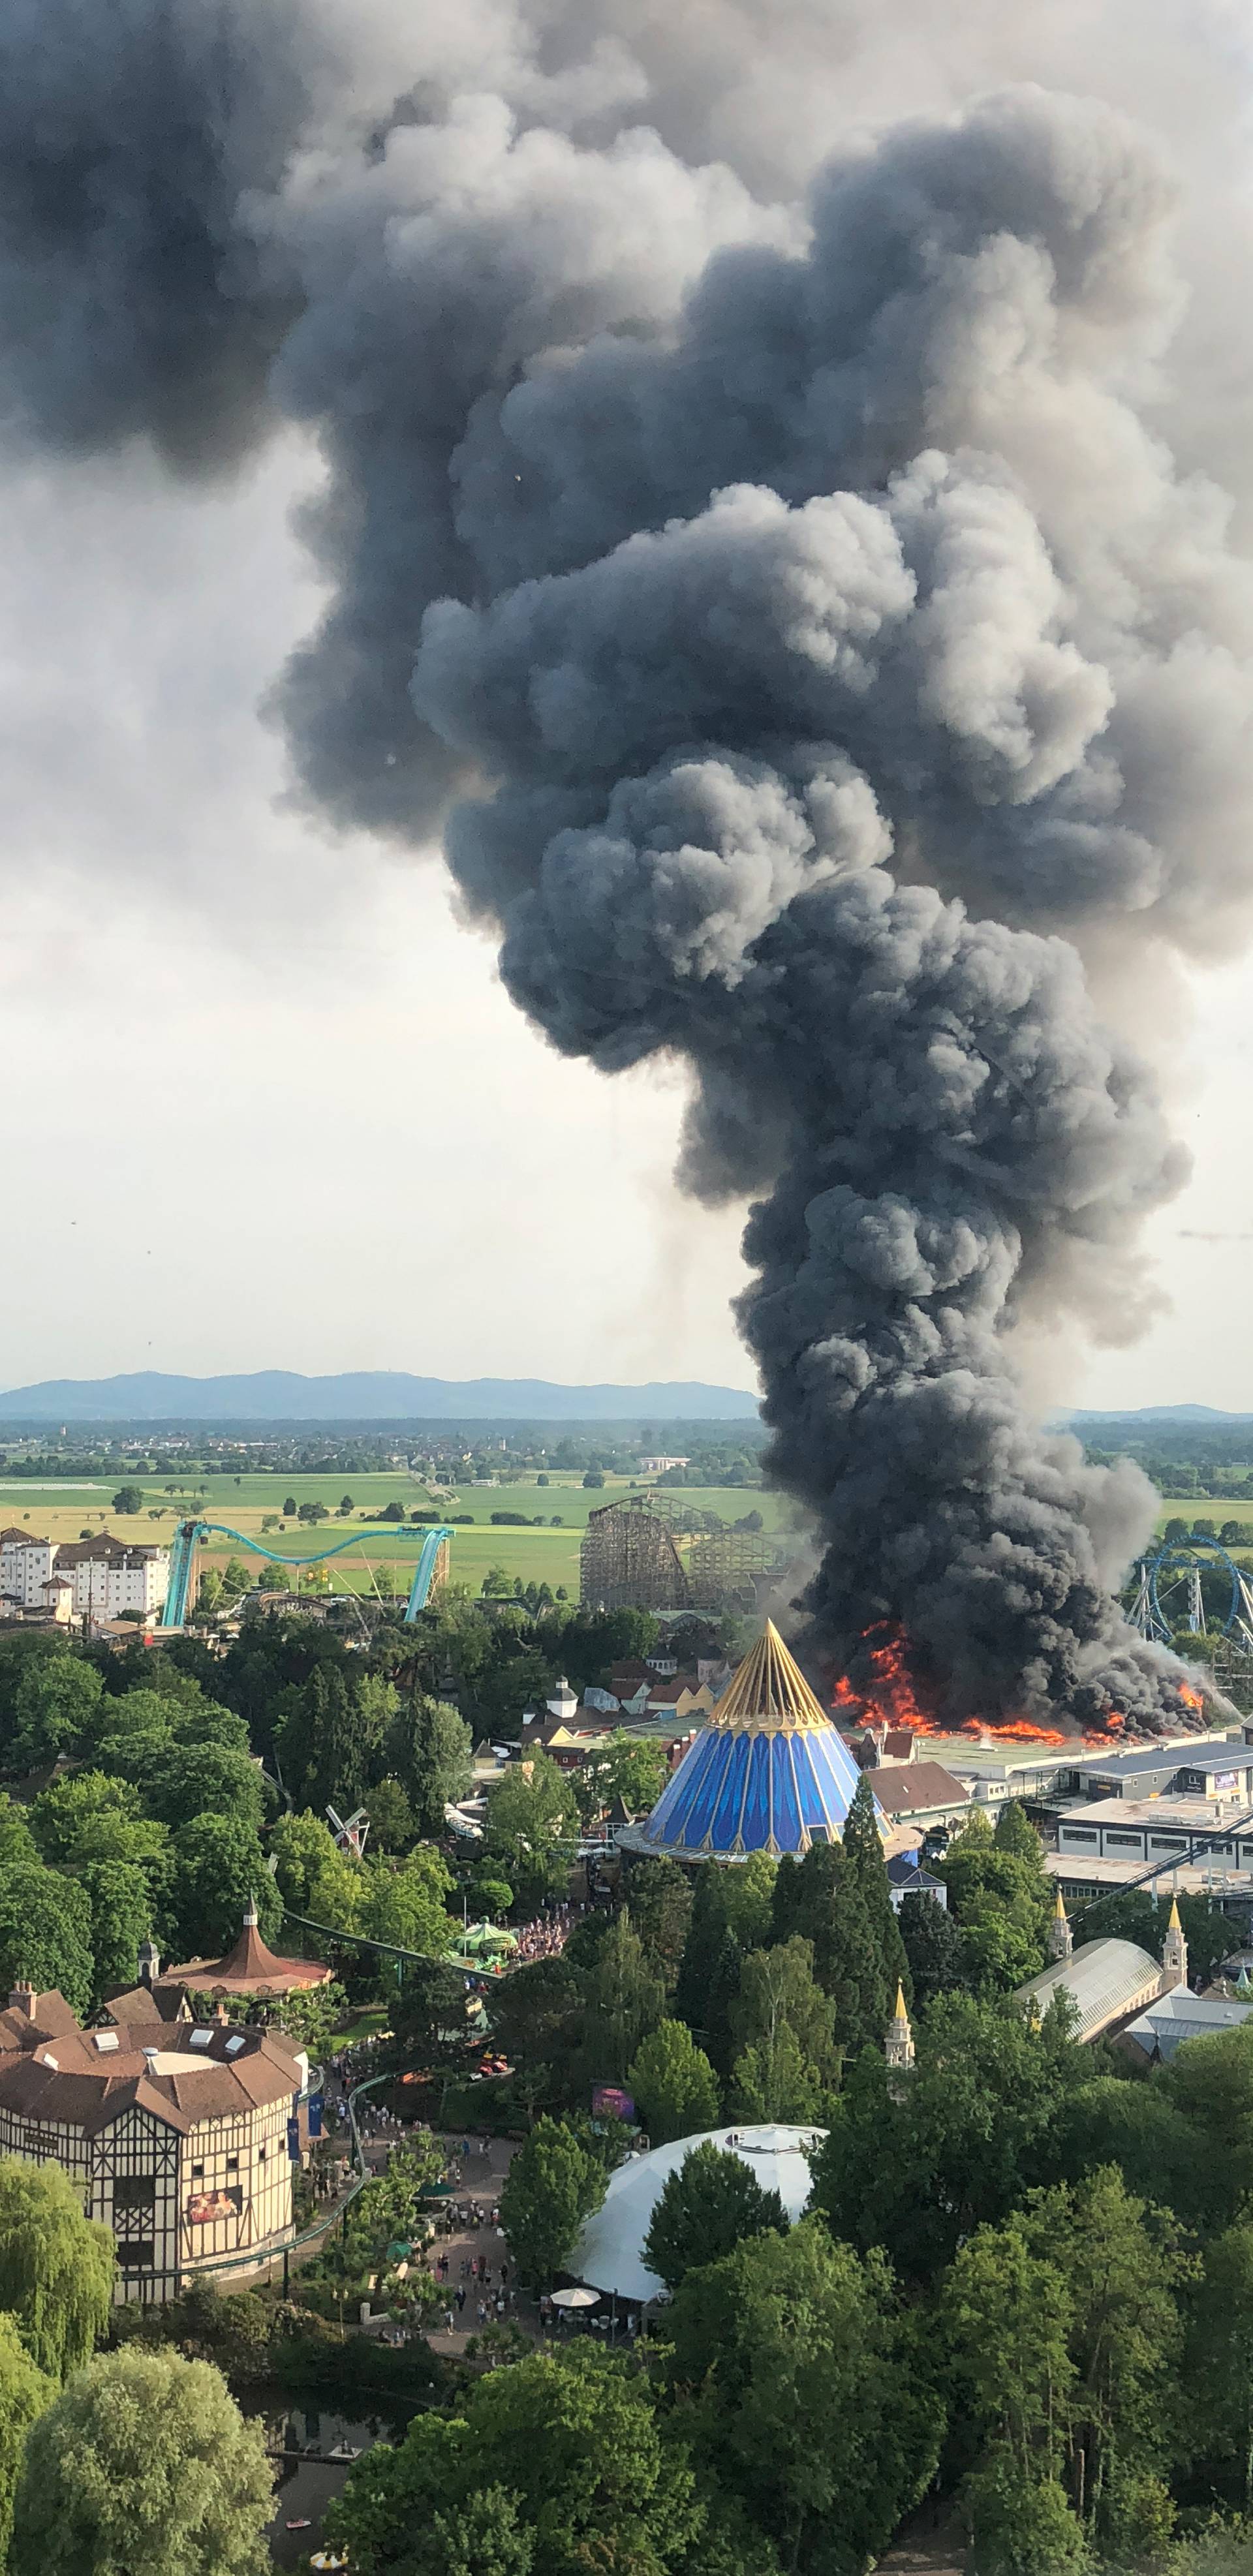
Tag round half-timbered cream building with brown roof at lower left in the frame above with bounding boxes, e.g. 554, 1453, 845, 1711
0, 1986, 309, 2303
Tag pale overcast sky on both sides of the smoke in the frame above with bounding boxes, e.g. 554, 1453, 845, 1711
0, 430, 1253, 1407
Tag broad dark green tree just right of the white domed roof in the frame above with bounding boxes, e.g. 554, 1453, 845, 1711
814, 1994, 1091, 2282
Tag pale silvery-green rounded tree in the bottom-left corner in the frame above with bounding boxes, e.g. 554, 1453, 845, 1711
13, 2347, 273, 2576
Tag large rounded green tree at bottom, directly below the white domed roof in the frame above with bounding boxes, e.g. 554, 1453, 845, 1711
665, 2218, 941, 2576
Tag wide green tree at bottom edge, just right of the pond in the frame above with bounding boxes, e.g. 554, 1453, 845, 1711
325, 2344, 699, 2576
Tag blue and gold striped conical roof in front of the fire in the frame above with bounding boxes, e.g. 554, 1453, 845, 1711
637, 1620, 859, 1860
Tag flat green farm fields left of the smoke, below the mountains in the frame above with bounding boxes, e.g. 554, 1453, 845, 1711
0, 1471, 794, 1600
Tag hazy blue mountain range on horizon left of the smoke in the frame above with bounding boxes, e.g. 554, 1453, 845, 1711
0, 1368, 758, 1422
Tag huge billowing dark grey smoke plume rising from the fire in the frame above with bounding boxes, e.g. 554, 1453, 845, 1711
0, 0, 1253, 1728
